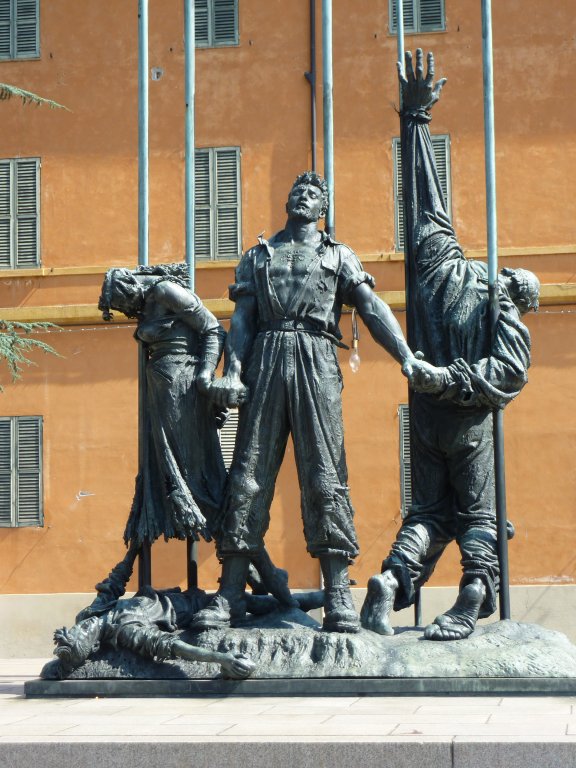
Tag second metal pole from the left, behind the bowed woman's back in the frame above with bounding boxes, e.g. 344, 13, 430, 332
184, 0, 198, 589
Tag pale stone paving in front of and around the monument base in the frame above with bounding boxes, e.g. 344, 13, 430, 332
0, 659, 576, 768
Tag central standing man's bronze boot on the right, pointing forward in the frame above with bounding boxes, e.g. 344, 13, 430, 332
320, 555, 360, 632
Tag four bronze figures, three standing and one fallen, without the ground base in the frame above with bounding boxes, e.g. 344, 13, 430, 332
46, 50, 539, 677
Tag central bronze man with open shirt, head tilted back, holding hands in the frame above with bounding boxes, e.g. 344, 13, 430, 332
194, 172, 413, 632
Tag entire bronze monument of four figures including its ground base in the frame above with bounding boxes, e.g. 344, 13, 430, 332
27, 50, 576, 695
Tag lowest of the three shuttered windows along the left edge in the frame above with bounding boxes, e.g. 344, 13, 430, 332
0, 416, 44, 528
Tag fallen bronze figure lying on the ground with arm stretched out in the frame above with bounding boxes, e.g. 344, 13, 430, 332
40, 587, 324, 679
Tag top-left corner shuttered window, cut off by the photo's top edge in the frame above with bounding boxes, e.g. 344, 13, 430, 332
0, 0, 40, 60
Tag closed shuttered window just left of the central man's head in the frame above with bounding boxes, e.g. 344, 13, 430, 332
194, 147, 241, 259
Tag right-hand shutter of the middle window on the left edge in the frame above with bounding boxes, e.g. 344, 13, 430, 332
15, 159, 40, 269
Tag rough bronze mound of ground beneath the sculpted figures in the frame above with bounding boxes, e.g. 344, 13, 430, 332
39, 610, 576, 680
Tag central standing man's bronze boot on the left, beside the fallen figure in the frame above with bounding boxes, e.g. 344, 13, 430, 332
190, 555, 250, 630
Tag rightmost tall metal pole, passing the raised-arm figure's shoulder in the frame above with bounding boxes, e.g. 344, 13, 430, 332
482, 0, 510, 619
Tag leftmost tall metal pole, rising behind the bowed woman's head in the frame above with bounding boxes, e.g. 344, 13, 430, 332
138, 0, 152, 587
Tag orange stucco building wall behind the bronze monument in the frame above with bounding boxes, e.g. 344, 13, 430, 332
0, 0, 576, 593
